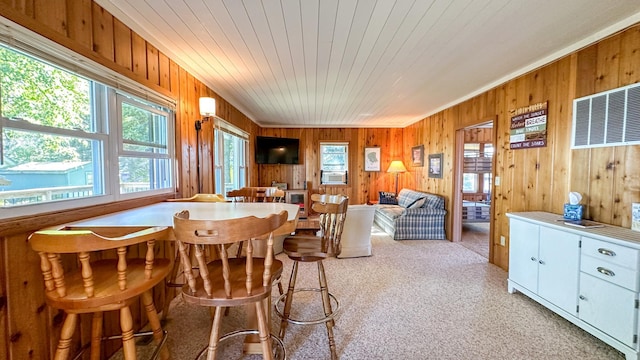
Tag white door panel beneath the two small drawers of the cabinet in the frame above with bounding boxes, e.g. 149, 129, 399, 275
578, 273, 638, 347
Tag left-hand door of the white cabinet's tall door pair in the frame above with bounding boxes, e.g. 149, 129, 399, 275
509, 219, 540, 293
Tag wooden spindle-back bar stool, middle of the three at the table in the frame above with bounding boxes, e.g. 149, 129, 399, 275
173, 211, 287, 360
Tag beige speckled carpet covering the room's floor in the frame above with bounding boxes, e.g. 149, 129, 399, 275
115, 226, 624, 360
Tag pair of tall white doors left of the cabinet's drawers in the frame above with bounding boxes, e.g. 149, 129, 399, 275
509, 219, 580, 314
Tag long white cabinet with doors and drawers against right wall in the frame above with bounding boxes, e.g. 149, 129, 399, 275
507, 212, 640, 360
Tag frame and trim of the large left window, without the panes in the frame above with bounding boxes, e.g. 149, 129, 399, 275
0, 29, 177, 219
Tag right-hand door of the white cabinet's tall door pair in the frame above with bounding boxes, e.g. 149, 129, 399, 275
538, 226, 580, 315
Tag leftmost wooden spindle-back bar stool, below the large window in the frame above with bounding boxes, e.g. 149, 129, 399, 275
29, 227, 171, 360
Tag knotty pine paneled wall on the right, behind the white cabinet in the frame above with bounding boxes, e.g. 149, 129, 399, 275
404, 24, 640, 270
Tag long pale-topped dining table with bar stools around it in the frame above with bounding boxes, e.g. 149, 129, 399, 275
58, 202, 299, 354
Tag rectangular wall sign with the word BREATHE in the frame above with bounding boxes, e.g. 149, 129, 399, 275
509, 102, 547, 150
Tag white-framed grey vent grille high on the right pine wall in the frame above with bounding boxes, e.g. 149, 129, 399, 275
571, 84, 640, 149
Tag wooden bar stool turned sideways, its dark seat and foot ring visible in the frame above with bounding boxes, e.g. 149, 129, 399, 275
276, 194, 349, 359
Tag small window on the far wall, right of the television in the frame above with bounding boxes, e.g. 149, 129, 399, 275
320, 142, 349, 184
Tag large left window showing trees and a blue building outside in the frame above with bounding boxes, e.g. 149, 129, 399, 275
0, 44, 175, 218
